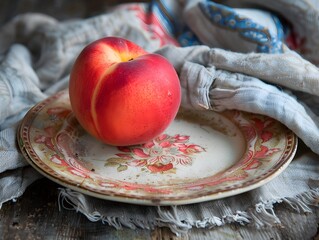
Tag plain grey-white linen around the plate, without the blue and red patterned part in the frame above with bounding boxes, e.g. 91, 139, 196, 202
0, 1, 319, 237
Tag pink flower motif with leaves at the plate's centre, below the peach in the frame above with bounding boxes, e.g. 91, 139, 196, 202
105, 134, 205, 173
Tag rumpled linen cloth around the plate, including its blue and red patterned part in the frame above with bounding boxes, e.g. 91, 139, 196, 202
0, 0, 319, 237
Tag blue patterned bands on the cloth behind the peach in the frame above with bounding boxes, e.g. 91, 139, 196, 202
154, 0, 284, 53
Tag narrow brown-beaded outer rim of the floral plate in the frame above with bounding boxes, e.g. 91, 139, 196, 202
17, 90, 298, 206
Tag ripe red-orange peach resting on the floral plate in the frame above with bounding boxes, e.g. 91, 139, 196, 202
69, 37, 181, 146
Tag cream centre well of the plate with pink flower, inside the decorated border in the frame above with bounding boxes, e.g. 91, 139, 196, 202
73, 110, 246, 185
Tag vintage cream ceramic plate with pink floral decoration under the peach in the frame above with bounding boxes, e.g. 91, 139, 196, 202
18, 90, 297, 205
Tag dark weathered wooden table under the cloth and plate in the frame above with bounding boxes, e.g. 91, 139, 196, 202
0, 178, 319, 240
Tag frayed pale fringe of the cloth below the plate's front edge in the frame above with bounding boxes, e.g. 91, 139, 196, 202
58, 188, 319, 236
